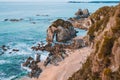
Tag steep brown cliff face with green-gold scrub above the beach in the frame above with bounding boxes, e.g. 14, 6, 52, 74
69, 5, 120, 80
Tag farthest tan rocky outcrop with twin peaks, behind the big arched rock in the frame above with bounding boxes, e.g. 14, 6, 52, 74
69, 9, 92, 30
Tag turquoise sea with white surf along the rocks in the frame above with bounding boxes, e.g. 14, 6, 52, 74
0, 3, 116, 80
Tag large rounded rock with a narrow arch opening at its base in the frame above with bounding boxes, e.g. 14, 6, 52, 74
46, 19, 76, 42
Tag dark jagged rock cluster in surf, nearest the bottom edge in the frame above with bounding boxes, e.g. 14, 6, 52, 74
22, 54, 42, 78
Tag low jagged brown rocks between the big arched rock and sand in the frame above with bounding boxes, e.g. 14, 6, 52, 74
32, 43, 69, 66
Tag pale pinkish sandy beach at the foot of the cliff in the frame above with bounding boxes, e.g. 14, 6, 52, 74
22, 47, 91, 80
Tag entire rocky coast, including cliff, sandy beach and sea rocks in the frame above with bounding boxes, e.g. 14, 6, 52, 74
0, 5, 120, 80
